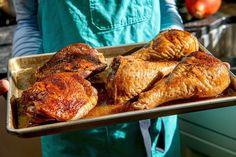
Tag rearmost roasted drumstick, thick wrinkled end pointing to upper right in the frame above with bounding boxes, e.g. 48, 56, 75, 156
133, 29, 199, 61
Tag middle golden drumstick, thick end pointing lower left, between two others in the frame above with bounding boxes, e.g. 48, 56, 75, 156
106, 56, 178, 103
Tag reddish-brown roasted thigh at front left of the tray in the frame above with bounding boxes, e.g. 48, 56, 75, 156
21, 72, 98, 123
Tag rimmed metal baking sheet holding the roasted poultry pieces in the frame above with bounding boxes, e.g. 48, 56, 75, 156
6, 43, 236, 137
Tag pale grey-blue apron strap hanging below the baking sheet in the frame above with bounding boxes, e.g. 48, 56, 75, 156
139, 119, 152, 157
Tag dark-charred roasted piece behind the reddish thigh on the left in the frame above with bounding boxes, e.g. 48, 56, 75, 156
35, 43, 107, 79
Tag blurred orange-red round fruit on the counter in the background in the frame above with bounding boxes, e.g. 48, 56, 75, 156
185, 0, 222, 19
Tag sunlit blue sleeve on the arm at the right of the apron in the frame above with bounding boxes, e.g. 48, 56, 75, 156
160, 0, 183, 31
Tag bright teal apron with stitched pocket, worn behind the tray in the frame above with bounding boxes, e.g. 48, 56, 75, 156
38, 0, 179, 157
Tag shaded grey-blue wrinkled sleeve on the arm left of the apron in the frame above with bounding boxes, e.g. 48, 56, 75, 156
12, 0, 42, 56
